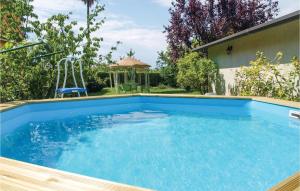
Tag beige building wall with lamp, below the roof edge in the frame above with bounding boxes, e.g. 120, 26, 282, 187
208, 19, 299, 95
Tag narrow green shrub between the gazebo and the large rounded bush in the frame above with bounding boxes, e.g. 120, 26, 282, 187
156, 51, 177, 87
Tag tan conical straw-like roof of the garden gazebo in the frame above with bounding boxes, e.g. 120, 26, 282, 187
110, 57, 150, 69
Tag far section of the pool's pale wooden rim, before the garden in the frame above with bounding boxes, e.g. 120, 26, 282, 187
0, 93, 300, 113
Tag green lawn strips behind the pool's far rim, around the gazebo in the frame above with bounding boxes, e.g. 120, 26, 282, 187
89, 87, 200, 96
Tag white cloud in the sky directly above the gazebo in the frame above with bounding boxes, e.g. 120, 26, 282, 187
100, 15, 166, 65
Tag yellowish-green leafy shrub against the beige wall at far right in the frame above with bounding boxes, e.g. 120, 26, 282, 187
235, 52, 300, 100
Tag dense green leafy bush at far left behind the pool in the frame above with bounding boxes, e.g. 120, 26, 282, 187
0, 43, 56, 102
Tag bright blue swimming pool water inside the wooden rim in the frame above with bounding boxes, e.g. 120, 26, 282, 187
1, 97, 300, 191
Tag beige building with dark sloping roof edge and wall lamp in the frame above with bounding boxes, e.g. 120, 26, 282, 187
194, 11, 300, 95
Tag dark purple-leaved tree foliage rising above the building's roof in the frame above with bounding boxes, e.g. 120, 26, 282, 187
165, 0, 278, 60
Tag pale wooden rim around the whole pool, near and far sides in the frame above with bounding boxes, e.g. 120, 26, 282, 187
0, 94, 300, 191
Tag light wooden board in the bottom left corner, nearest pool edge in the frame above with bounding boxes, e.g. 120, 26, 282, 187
0, 157, 150, 191
